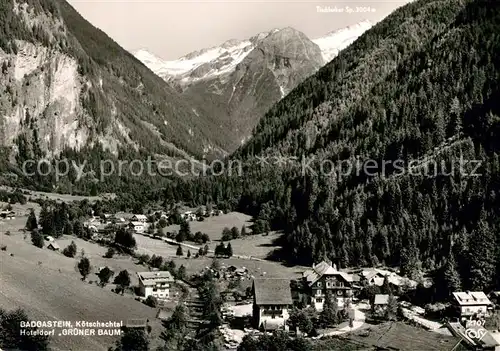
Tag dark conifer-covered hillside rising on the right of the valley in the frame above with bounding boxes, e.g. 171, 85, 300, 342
162, 0, 500, 289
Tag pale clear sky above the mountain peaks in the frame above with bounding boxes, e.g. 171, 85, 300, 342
69, 0, 409, 60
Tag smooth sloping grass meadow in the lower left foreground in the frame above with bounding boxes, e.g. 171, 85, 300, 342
0, 234, 156, 350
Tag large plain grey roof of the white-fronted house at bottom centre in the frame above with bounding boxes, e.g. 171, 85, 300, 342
253, 278, 293, 305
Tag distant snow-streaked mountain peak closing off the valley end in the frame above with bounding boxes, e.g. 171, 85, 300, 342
134, 21, 372, 152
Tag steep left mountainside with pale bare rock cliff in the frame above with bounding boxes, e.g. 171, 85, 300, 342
0, 0, 225, 162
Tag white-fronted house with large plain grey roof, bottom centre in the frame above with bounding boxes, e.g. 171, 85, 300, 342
252, 278, 293, 330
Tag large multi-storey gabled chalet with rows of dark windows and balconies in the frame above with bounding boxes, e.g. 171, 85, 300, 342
302, 261, 353, 311
